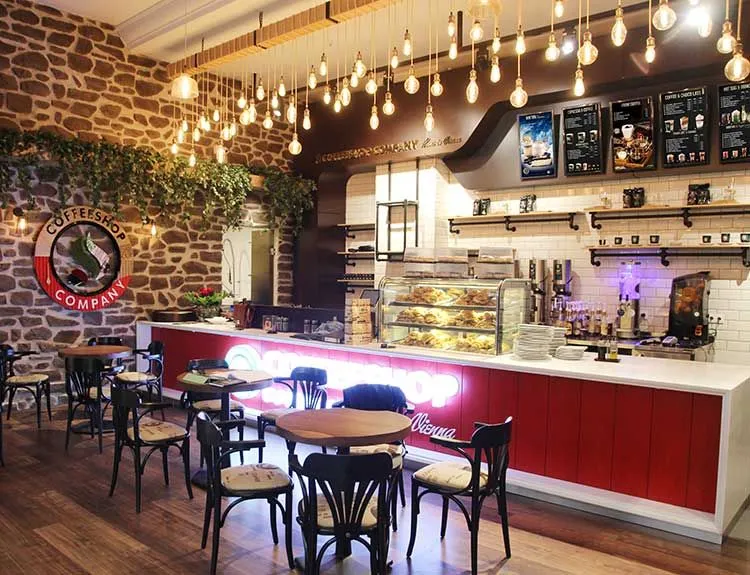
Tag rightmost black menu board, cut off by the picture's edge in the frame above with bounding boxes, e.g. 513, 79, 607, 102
719, 83, 750, 164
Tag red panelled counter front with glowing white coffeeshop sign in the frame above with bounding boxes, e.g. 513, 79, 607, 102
152, 327, 722, 513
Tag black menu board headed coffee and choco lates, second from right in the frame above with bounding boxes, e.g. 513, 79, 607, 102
661, 88, 708, 168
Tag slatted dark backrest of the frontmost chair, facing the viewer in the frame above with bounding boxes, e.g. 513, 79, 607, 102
293, 453, 395, 537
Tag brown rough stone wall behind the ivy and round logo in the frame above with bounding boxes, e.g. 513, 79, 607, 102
0, 0, 292, 410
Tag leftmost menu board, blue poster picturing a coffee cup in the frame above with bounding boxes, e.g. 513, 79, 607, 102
518, 111, 557, 180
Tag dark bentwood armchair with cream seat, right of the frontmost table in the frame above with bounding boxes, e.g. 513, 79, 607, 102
406, 417, 513, 575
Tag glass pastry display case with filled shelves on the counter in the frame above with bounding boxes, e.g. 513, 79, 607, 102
379, 277, 531, 355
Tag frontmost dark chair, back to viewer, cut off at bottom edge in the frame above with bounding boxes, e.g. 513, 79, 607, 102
289, 453, 393, 575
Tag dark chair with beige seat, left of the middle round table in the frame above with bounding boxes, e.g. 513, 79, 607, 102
109, 385, 193, 513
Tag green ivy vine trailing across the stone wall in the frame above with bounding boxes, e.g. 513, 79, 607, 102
0, 130, 316, 235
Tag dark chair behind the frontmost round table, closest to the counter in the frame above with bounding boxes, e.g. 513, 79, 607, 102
333, 383, 414, 531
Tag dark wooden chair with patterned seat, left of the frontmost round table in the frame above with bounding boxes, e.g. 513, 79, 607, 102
197, 412, 294, 575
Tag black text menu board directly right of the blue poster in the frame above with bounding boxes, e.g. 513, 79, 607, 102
563, 104, 604, 176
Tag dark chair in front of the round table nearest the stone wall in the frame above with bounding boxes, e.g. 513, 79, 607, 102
65, 357, 109, 453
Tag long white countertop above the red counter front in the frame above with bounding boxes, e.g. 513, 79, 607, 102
138, 321, 750, 395
